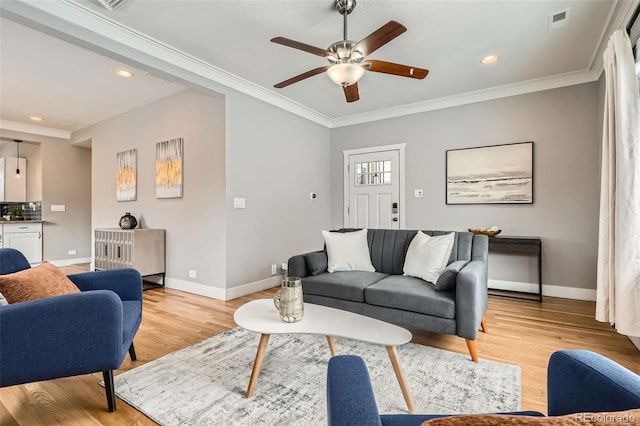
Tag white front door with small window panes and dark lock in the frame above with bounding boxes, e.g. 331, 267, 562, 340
345, 149, 402, 229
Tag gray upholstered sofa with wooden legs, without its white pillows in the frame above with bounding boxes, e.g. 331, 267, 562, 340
288, 229, 489, 362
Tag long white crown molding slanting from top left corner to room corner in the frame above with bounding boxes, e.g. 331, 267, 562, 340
0, 0, 331, 127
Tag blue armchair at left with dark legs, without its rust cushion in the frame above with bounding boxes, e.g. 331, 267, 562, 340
0, 248, 142, 412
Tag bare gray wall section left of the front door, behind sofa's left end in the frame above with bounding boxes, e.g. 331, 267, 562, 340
226, 93, 331, 287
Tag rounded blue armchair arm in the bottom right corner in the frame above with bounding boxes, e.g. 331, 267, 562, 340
547, 350, 640, 416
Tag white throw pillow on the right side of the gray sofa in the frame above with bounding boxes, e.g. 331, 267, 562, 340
403, 231, 456, 284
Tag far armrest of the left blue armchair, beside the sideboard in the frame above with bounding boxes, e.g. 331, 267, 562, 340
69, 268, 142, 300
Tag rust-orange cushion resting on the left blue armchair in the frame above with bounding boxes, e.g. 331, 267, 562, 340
0, 262, 80, 303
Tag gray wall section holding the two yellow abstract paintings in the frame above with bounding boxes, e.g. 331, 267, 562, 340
73, 90, 226, 288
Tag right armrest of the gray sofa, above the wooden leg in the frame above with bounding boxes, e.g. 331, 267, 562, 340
456, 260, 488, 340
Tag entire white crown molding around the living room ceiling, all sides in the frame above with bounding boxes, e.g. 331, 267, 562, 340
0, 0, 624, 128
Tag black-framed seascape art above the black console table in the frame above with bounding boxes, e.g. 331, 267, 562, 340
446, 142, 533, 204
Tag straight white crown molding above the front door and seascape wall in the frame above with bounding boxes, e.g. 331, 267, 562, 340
331, 70, 599, 128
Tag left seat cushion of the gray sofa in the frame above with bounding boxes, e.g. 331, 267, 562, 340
302, 271, 387, 302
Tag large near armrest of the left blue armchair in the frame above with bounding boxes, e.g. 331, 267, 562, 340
0, 290, 124, 386
